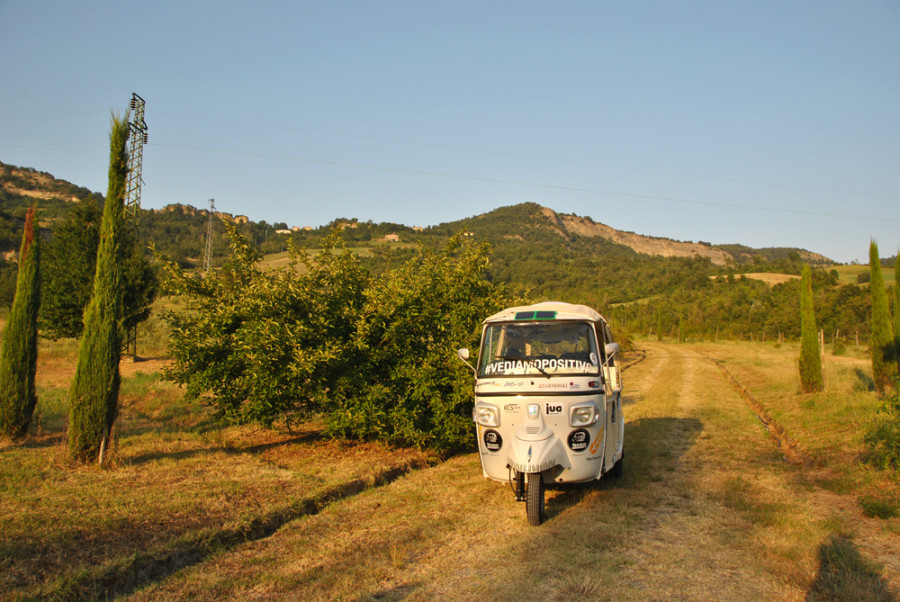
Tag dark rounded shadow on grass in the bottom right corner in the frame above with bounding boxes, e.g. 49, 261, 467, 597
806, 535, 897, 602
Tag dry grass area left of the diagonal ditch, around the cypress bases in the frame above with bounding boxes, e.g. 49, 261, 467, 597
0, 341, 428, 598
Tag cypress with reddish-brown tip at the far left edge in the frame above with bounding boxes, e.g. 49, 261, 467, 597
0, 205, 41, 439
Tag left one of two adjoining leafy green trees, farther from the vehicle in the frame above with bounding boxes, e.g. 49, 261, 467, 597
165, 222, 367, 424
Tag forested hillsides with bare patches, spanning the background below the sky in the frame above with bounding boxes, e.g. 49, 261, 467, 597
0, 164, 893, 343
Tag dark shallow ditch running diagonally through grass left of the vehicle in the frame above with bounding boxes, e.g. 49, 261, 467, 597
27, 458, 439, 600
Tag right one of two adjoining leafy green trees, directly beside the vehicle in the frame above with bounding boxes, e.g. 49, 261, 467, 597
328, 237, 513, 452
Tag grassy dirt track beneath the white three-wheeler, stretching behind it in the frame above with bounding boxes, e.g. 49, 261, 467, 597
130, 345, 900, 600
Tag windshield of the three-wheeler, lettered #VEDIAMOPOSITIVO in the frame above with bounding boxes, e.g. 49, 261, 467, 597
478, 322, 600, 377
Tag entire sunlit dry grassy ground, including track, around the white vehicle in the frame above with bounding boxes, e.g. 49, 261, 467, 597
0, 330, 900, 600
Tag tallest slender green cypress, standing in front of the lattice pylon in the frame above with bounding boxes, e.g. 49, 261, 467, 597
68, 116, 128, 462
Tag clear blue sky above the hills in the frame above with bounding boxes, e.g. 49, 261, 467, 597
0, 0, 900, 263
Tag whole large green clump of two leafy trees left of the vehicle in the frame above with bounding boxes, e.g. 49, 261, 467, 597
166, 226, 507, 452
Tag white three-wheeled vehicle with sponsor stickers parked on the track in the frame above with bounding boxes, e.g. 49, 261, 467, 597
459, 302, 625, 525
